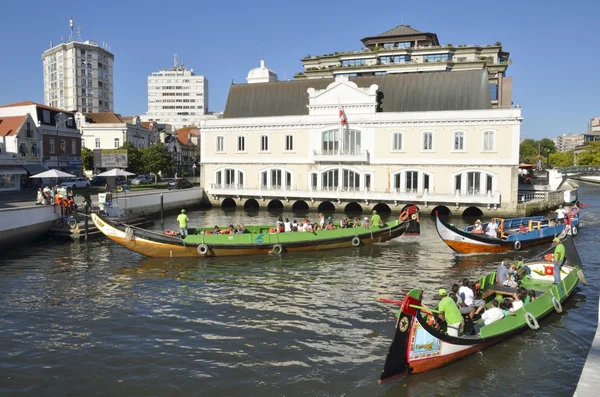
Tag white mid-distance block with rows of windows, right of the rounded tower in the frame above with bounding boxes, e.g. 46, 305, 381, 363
144, 58, 208, 129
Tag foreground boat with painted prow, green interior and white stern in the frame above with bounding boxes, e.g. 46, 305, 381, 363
379, 235, 585, 383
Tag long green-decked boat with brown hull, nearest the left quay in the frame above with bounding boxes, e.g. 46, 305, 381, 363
91, 214, 408, 258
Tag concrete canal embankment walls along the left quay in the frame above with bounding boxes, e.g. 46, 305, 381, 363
0, 188, 208, 249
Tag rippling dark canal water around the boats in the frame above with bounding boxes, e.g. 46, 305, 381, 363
0, 185, 600, 397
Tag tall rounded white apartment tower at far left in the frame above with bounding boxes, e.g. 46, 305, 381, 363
42, 30, 115, 113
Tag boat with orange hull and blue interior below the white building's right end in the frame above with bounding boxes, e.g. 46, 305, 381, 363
436, 214, 579, 255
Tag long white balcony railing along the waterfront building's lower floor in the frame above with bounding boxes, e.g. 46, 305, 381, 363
207, 183, 501, 205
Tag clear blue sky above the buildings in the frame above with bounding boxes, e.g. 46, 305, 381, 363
0, 0, 600, 139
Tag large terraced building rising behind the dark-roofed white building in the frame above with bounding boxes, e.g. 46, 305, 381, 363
294, 25, 512, 108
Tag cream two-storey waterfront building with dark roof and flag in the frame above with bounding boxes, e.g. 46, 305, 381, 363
200, 69, 522, 215
